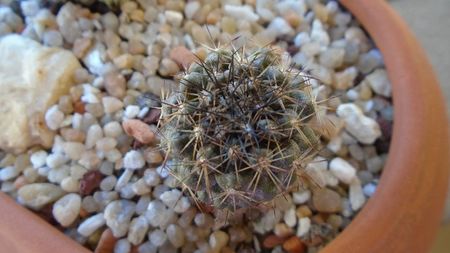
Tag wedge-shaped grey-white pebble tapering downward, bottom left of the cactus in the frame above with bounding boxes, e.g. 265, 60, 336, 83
104, 200, 136, 238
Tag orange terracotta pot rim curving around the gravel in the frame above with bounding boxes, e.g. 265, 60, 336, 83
0, 0, 450, 253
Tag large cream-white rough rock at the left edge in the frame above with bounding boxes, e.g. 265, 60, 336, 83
0, 35, 80, 153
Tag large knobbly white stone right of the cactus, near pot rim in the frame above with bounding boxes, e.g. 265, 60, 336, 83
336, 103, 381, 144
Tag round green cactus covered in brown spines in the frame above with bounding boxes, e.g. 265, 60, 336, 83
159, 45, 320, 211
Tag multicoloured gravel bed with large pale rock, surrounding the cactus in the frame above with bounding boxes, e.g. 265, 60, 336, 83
0, 0, 393, 253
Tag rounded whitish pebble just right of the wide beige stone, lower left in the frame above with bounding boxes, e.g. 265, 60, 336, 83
52, 193, 81, 227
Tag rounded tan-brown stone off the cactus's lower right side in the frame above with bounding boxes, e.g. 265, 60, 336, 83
312, 188, 341, 213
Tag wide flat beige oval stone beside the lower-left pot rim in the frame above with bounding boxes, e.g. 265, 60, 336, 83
17, 183, 64, 209
